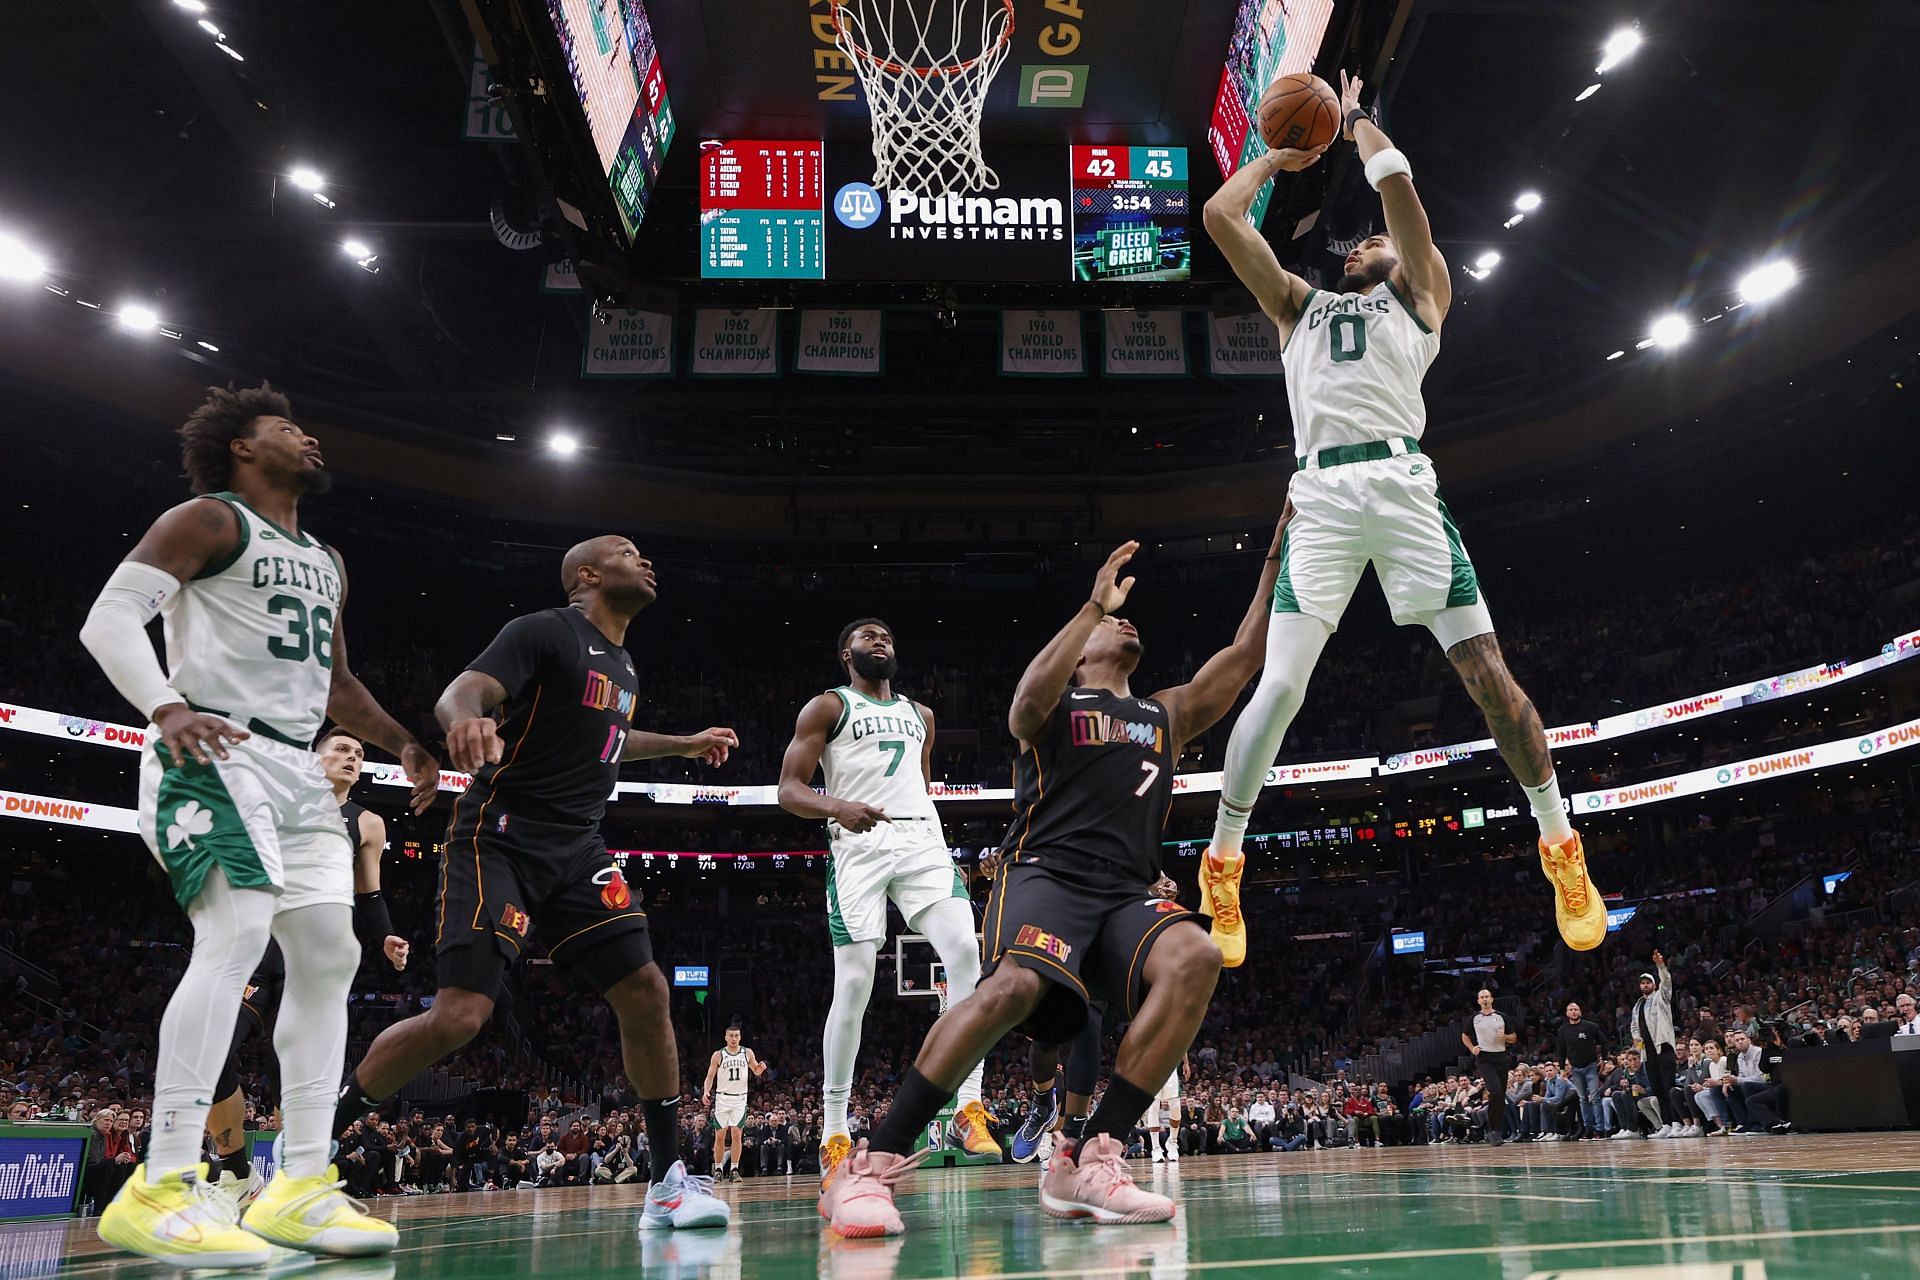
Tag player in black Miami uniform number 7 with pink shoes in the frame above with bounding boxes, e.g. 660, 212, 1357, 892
820, 516, 1286, 1236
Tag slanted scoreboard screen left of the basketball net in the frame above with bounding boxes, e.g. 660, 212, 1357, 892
547, 0, 674, 240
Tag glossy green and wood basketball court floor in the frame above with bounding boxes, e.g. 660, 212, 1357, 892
22, 1134, 1920, 1280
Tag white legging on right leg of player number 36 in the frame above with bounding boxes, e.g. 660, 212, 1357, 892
273, 902, 359, 1178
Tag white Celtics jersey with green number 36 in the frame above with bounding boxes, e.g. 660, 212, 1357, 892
161, 493, 340, 747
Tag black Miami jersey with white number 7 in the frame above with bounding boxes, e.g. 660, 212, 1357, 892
1000, 689, 1175, 887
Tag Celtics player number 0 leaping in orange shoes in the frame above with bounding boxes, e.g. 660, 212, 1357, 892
1200, 73, 1607, 951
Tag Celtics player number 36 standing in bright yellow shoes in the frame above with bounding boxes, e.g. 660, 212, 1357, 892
81, 386, 440, 1267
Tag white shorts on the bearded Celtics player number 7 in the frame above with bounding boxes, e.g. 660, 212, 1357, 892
828, 819, 968, 946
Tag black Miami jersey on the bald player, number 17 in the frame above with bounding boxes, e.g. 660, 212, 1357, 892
461, 606, 639, 827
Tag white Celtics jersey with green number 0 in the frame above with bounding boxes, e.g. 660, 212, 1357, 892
1281, 280, 1440, 457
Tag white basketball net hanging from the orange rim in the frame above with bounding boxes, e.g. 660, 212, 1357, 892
829, 0, 1014, 196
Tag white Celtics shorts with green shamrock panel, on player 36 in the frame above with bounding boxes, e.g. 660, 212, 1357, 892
140, 725, 353, 912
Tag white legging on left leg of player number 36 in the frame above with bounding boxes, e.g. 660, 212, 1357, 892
146, 865, 273, 1182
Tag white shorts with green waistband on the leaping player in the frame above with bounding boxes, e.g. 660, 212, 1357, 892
1273, 439, 1494, 649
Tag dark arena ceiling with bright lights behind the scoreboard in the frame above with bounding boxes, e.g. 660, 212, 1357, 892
0, 0, 1920, 484
